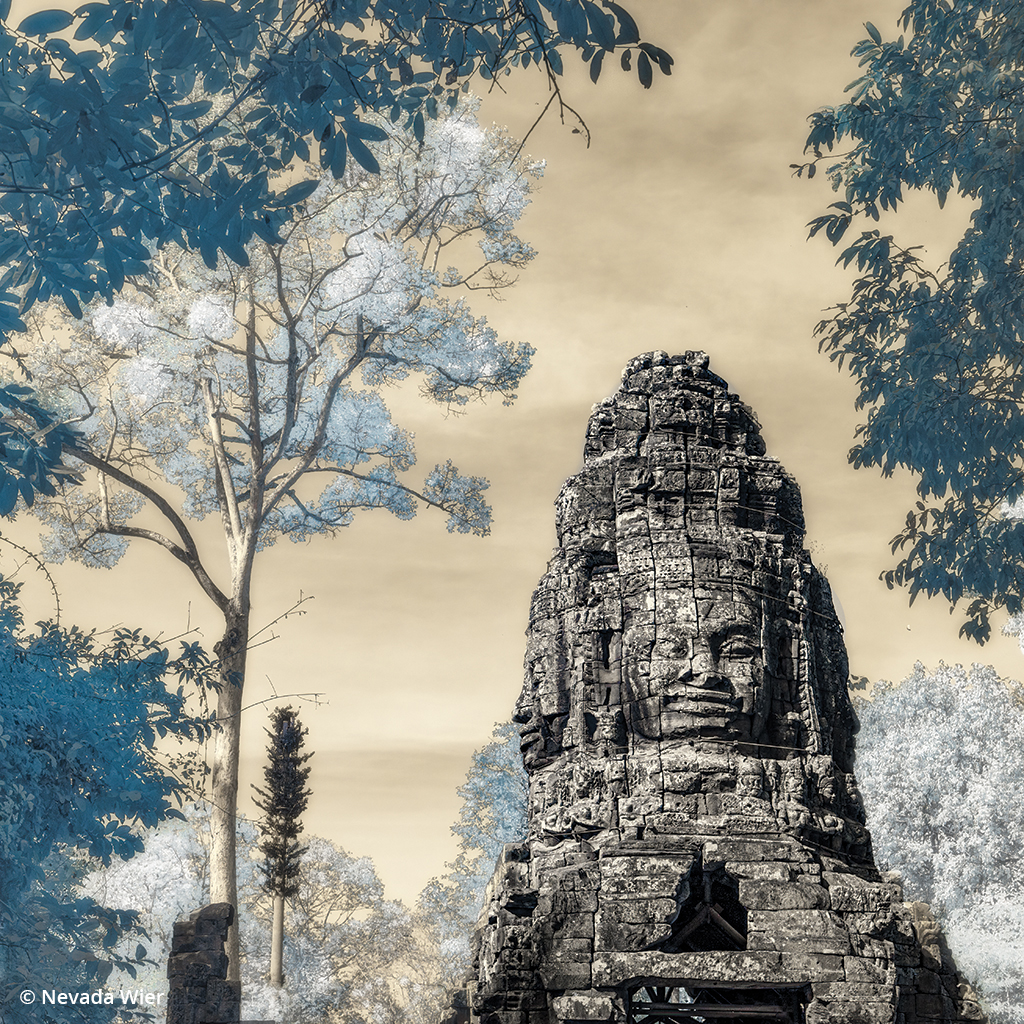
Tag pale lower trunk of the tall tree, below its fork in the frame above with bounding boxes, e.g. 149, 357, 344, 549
210, 587, 249, 981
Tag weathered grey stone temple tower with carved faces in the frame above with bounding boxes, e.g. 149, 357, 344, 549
471, 352, 983, 1024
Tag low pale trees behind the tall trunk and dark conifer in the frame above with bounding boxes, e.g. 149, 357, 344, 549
81, 803, 438, 1024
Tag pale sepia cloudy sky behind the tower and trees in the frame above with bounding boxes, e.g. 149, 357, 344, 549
9, 0, 1024, 901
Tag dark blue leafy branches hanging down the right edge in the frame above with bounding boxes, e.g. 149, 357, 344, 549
794, 0, 1024, 643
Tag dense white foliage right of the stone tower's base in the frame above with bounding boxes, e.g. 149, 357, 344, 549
856, 662, 1024, 1024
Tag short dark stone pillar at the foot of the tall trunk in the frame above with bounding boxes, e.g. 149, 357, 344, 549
167, 903, 242, 1024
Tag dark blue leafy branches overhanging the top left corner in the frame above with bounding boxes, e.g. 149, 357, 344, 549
0, 0, 672, 332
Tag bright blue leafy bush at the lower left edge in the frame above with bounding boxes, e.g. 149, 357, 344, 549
0, 578, 211, 1022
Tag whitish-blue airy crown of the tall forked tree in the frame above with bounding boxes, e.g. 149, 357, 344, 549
19, 99, 541, 571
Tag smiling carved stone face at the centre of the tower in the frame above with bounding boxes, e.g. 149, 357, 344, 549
626, 586, 770, 742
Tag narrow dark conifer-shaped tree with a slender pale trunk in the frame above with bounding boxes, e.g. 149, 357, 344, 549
253, 707, 312, 987
